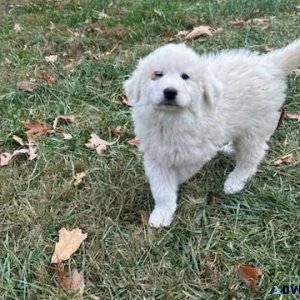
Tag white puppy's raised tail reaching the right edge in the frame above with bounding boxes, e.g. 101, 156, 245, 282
266, 39, 300, 74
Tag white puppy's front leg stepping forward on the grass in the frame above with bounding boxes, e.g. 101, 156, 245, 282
145, 159, 178, 228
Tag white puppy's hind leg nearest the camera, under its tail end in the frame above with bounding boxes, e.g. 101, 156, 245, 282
224, 133, 269, 194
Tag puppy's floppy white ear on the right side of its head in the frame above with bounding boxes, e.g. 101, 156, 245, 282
202, 71, 223, 108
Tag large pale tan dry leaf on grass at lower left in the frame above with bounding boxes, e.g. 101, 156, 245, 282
51, 227, 87, 264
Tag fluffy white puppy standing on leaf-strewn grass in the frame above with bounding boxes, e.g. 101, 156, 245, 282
124, 40, 300, 227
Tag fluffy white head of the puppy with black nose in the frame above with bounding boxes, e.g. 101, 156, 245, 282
124, 44, 221, 111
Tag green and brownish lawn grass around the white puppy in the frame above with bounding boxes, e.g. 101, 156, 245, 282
0, 0, 300, 299
